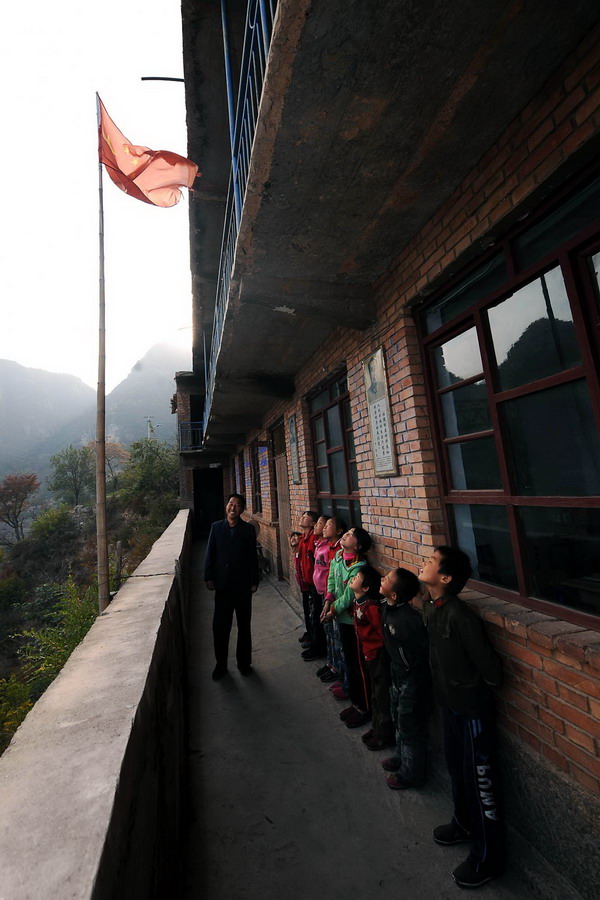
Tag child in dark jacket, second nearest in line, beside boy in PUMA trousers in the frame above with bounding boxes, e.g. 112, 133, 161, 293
381, 569, 431, 790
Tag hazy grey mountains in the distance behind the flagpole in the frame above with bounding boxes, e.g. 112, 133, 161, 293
0, 344, 190, 479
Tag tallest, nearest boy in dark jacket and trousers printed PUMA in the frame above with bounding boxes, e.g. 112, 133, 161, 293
419, 546, 504, 888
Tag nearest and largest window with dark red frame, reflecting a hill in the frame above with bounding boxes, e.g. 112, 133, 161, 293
421, 172, 600, 621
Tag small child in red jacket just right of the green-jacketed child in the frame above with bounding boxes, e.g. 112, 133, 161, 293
350, 566, 394, 750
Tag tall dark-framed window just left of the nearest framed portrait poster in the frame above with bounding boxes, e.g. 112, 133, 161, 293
309, 376, 361, 525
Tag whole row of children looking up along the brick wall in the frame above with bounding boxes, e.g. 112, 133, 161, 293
292, 512, 504, 888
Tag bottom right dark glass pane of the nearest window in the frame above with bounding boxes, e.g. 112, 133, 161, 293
519, 506, 600, 615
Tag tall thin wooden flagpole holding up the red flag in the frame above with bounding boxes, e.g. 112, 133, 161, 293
96, 94, 110, 612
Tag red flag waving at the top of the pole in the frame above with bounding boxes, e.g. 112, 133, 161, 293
98, 98, 198, 207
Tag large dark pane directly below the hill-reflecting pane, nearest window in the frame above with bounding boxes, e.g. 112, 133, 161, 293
502, 379, 600, 497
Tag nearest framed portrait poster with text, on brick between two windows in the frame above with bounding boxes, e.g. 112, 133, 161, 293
363, 347, 398, 476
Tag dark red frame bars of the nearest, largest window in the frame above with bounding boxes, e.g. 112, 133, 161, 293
415, 173, 600, 631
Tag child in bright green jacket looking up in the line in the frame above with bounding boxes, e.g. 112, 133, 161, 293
323, 527, 371, 728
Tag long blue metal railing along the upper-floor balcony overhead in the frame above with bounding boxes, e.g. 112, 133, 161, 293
204, 0, 277, 434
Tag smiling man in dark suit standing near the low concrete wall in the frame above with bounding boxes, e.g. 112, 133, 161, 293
204, 494, 259, 681
